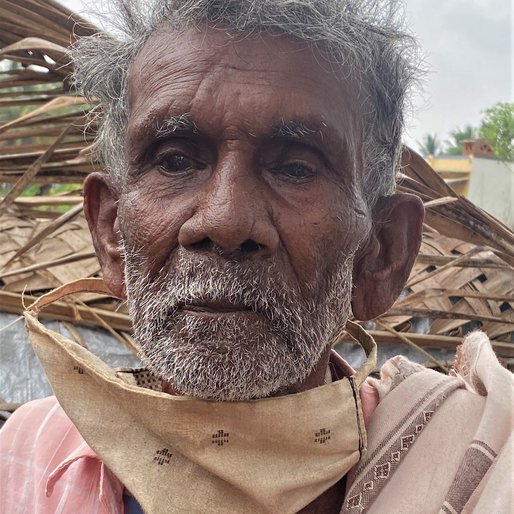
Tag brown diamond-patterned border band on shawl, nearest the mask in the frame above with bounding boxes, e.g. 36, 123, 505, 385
341, 380, 462, 514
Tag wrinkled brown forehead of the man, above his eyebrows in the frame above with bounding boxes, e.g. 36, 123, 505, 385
128, 25, 363, 164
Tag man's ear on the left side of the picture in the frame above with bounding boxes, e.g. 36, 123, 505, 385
84, 173, 126, 299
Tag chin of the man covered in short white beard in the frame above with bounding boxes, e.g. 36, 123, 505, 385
136, 314, 326, 401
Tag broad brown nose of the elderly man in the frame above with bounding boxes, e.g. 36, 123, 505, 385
178, 160, 279, 257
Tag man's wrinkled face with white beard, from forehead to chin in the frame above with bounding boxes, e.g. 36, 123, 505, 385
118, 25, 370, 400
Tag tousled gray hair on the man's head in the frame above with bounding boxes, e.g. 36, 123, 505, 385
72, 0, 419, 207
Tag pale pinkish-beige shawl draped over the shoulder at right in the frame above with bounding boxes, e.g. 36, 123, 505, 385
343, 332, 514, 514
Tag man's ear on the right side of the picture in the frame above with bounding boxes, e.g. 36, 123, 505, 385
352, 193, 424, 320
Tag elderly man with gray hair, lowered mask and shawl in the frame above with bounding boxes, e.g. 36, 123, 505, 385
0, 0, 512, 513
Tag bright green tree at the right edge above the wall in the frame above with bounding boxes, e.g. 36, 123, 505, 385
480, 102, 514, 161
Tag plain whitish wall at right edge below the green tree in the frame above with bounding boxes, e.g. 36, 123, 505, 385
468, 157, 514, 229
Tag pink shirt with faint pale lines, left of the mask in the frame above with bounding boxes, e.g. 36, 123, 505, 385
0, 396, 123, 514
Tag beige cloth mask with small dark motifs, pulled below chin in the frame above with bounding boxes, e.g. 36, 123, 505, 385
25, 279, 376, 514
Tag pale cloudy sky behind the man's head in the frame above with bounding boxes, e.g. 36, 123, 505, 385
60, 0, 514, 149
